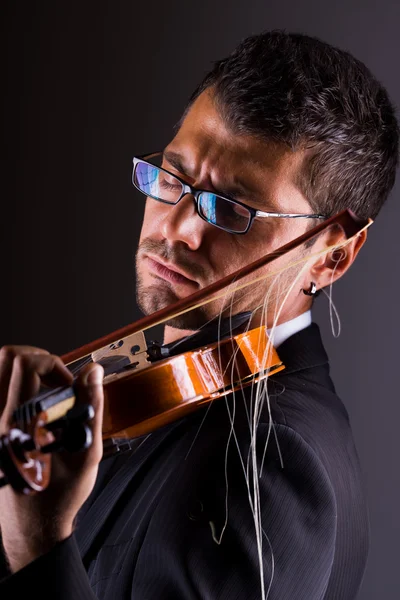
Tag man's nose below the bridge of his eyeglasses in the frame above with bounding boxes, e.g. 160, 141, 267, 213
161, 194, 211, 250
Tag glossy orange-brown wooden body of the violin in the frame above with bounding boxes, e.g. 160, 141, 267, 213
103, 327, 284, 439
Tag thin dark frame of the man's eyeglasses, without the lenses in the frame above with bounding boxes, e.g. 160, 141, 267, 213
132, 151, 328, 235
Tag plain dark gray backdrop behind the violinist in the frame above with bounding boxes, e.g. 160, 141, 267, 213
0, 0, 400, 600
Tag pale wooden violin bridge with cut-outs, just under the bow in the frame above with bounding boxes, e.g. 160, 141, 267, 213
91, 331, 150, 370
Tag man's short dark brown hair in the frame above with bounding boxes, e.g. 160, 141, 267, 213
185, 31, 399, 219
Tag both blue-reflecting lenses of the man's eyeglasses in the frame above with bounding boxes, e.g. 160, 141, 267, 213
134, 162, 251, 233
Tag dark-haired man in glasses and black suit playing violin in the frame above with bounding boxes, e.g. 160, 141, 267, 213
0, 31, 398, 600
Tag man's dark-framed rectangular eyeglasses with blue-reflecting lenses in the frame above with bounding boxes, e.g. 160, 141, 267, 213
132, 152, 327, 234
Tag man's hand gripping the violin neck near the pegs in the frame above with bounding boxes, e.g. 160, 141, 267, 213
0, 346, 103, 572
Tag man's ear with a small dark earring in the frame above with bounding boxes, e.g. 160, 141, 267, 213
309, 230, 367, 289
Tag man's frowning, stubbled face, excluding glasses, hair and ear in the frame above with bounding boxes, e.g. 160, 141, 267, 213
136, 90, 313, 329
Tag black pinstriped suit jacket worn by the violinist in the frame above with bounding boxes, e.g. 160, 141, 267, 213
0, 324, 368, 600
